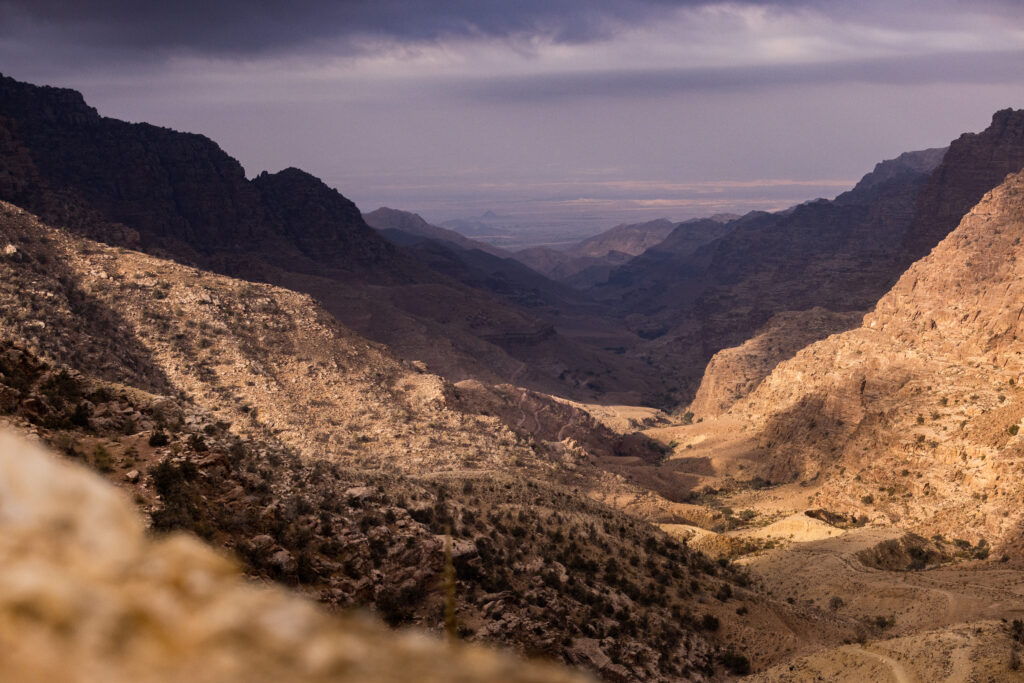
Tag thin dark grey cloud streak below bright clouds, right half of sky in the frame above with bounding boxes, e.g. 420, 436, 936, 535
451, 50, 1024, 102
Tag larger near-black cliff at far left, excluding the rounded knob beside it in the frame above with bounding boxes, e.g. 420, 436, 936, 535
0, 72, 271, 251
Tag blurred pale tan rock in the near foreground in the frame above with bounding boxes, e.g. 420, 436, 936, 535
0, 433, 584, 683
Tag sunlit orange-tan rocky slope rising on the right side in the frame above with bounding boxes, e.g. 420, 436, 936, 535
733, 169, 1024, 544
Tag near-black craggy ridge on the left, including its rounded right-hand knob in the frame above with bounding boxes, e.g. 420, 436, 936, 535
0, 71, 403, 269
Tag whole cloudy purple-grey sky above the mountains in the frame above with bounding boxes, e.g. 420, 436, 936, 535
0, 0, 1024, 240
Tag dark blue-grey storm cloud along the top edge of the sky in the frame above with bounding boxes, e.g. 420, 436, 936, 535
0, 0, 793, 55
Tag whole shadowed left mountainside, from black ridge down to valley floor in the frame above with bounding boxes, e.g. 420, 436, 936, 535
0, 77, 660, 400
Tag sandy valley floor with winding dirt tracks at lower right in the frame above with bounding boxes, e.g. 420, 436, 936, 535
632, 416, 1024, 683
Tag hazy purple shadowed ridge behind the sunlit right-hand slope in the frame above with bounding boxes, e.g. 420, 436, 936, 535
593, 143, 991, 401
